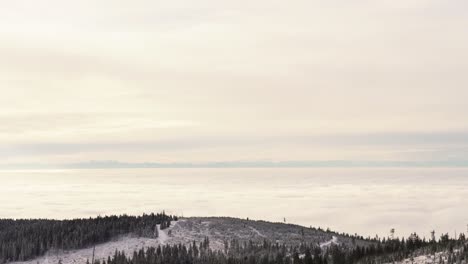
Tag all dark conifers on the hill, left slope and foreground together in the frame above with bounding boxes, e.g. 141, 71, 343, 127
0, 212, 468, 264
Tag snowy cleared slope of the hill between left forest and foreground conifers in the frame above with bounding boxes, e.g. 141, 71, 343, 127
7, 217, 368, 264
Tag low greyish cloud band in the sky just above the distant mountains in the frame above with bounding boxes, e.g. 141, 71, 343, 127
0, 132, 468, 167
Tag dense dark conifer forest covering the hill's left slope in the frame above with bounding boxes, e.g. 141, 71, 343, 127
0, 213, 174, 263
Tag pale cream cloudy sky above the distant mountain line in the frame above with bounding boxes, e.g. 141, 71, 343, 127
0, 0, 468, 167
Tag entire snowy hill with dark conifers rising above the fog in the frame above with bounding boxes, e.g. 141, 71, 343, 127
0, 216, 468, 264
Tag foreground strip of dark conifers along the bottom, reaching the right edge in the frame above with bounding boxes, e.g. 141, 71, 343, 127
95, 234, 468, 264
